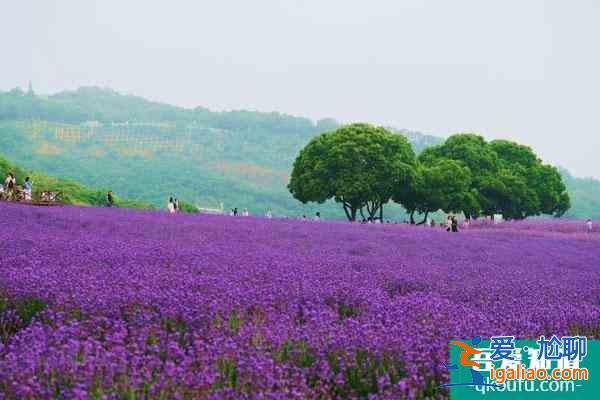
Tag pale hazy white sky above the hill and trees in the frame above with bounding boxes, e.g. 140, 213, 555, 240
0, 0, 600, 177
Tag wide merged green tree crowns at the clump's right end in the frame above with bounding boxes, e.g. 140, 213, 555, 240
417, 134, 570, 219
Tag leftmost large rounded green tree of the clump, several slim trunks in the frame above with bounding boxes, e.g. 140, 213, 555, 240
288, 124, 416, 221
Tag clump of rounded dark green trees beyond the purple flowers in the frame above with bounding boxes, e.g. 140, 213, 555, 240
288, 124, 570, 223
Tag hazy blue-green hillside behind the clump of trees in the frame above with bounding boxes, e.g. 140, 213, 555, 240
0, 87, 600, 218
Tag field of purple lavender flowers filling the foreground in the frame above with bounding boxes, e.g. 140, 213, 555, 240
0, 204, 600, 399
